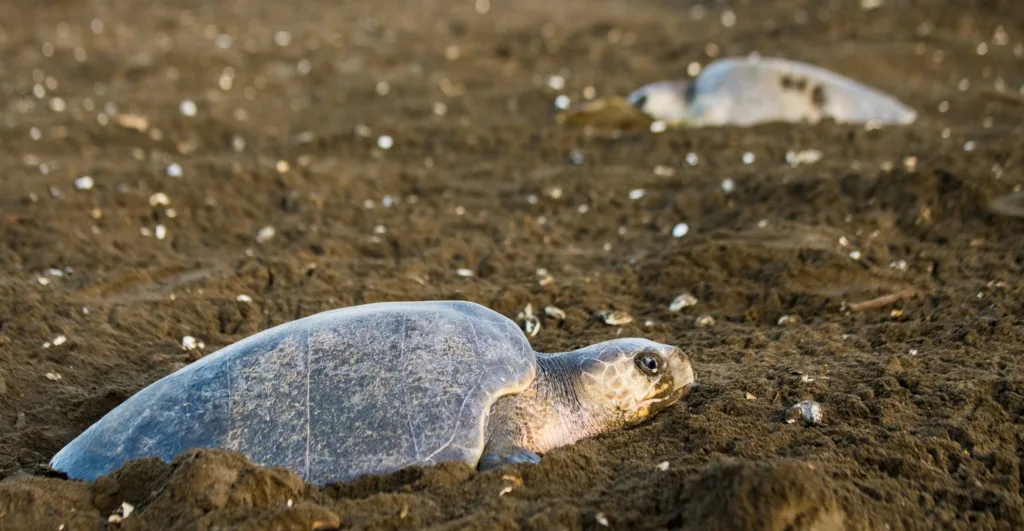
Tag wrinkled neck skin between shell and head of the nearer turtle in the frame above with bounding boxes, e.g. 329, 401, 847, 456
488, 352, 625, 453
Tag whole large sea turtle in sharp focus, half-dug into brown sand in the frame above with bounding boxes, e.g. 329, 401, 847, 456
50, 301, 693, 484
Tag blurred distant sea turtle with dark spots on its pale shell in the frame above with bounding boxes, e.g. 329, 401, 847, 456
627, 55, 918, 127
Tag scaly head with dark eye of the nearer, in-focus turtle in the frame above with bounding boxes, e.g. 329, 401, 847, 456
575, 338, 693, 426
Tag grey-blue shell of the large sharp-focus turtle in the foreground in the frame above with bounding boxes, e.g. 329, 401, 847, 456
50, 301, 537, 484
